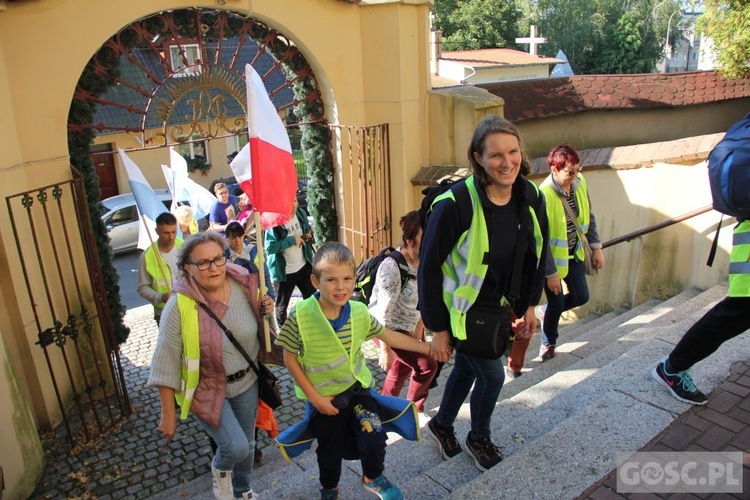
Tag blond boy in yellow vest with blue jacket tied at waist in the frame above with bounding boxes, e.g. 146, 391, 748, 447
276, 242, 448, 500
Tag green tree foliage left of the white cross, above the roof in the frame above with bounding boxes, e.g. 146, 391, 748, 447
433, 0, 521, 50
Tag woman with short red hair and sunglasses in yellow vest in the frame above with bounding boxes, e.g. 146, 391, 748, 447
508, 144, 604, 376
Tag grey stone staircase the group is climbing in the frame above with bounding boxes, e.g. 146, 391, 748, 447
158, 284, 750, 500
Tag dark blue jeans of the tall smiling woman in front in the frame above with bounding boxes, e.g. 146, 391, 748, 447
435, 352, 505, 441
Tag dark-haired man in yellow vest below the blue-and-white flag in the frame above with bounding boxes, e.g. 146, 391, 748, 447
138, 212, 182, 325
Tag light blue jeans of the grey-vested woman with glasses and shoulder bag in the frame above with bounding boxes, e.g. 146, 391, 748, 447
198, 382, 258, 497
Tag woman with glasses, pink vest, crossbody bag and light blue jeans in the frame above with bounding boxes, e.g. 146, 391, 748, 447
148, 233, 282, 500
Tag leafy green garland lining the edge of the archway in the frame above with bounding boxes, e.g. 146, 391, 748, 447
68, 9, 338, 343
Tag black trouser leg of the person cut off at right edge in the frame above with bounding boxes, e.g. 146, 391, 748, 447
669, 297, 750, 373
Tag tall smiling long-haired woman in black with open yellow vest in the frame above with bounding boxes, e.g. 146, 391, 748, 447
417, 115, 549, 471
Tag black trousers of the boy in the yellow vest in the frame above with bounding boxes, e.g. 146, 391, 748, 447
308, 390, 388, 489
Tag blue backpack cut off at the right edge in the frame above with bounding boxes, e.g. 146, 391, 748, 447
708, 114, 750, 219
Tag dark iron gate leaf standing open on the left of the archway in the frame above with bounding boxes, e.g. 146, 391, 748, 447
6, 169, 130, 445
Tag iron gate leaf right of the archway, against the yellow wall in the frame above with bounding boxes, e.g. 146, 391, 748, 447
331, 124, 393, 262
